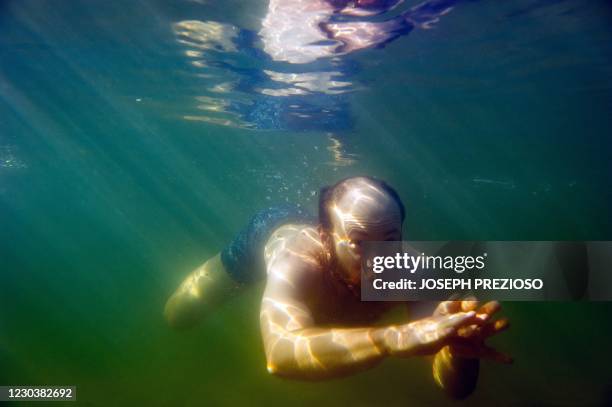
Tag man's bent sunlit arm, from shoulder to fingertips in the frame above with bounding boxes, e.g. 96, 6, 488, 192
261, 254, 478, 380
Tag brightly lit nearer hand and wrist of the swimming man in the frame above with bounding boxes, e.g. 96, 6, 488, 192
382, 310, 484, 357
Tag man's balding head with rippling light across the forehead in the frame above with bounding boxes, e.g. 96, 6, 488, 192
329, 184, 402, 286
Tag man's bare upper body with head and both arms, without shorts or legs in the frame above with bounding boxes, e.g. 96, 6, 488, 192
260, 181, 507, 388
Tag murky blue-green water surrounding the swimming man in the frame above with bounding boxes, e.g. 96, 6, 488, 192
0, 0, 612, 406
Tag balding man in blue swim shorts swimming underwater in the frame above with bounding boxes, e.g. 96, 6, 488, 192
165, 177, 510, 398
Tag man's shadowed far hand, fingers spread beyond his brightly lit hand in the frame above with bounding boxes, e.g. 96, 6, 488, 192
434, 299, 512, 363
